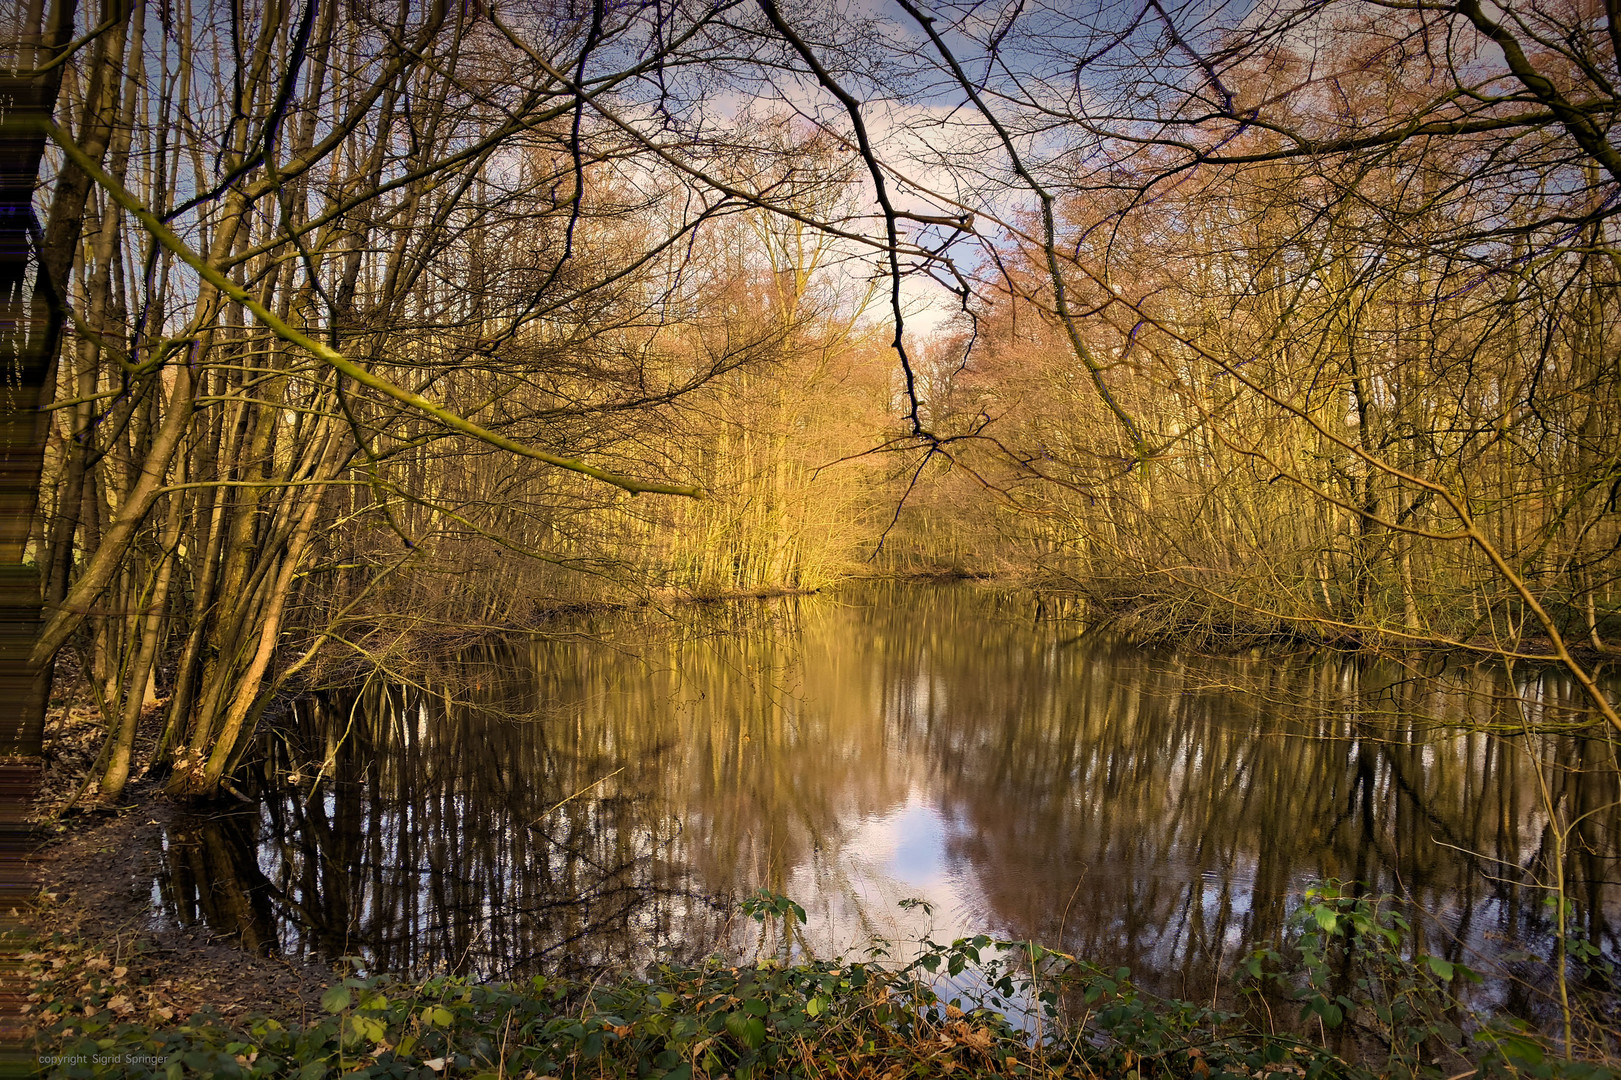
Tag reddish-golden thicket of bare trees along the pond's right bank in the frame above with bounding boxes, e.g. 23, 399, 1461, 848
875, 14, 1621, 657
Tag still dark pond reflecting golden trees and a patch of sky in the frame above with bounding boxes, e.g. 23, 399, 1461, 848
152, 584, 1621, 1014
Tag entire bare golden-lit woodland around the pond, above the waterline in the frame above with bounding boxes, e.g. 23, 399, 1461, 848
0, 0, 1621, 798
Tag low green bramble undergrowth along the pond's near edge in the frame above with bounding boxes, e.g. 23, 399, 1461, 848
39, 884, 1621, 1080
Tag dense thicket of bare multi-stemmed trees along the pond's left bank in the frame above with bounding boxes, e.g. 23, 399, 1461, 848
3, 2, 887, 796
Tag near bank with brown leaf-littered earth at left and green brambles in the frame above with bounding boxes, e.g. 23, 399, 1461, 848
26, 820, 1621, 1080
